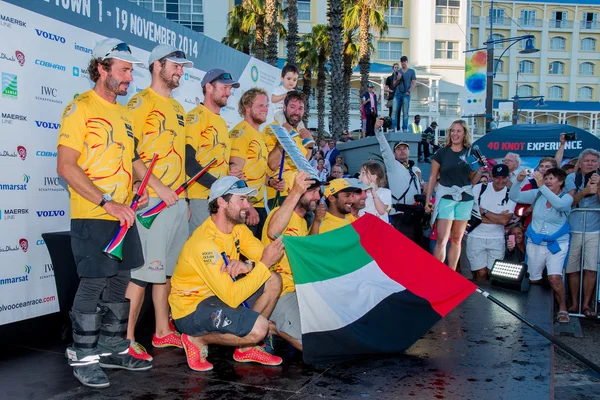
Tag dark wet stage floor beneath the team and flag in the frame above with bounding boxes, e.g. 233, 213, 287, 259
0, 286, 553, 400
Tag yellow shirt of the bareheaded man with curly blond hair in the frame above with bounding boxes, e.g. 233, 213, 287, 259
229, 120, 269, 207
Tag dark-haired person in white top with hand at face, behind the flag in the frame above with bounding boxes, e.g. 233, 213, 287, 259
358, 161, 392, 223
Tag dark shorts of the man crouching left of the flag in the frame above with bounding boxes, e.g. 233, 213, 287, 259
174, 285, 264, 337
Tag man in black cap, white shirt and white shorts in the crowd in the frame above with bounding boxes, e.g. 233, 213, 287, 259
467, 164, 516, 280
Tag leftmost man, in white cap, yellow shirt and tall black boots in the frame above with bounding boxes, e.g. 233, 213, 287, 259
57, 39, 152, 388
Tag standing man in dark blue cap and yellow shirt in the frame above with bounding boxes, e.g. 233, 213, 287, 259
185, 69, 240, 231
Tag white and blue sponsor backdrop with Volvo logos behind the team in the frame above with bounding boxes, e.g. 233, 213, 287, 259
0, 0, 280, 325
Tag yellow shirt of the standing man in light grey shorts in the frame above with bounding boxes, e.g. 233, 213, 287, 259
127, 88, 185, 197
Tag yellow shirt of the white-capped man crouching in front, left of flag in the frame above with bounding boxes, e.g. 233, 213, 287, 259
169, 218, 271, 319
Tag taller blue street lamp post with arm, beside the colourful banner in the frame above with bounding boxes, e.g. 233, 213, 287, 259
483, 1, 540, 133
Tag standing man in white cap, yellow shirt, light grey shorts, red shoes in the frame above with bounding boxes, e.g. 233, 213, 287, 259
126, 44, 194, 360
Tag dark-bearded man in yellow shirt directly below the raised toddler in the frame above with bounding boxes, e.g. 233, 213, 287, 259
263, 90, 315, 208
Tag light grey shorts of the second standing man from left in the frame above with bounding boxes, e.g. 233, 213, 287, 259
131, 197, 189, 283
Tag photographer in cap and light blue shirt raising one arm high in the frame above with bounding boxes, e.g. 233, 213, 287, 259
375, 117, 425, 246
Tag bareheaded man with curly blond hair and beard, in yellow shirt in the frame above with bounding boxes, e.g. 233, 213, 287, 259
229, 88, 284, 239
